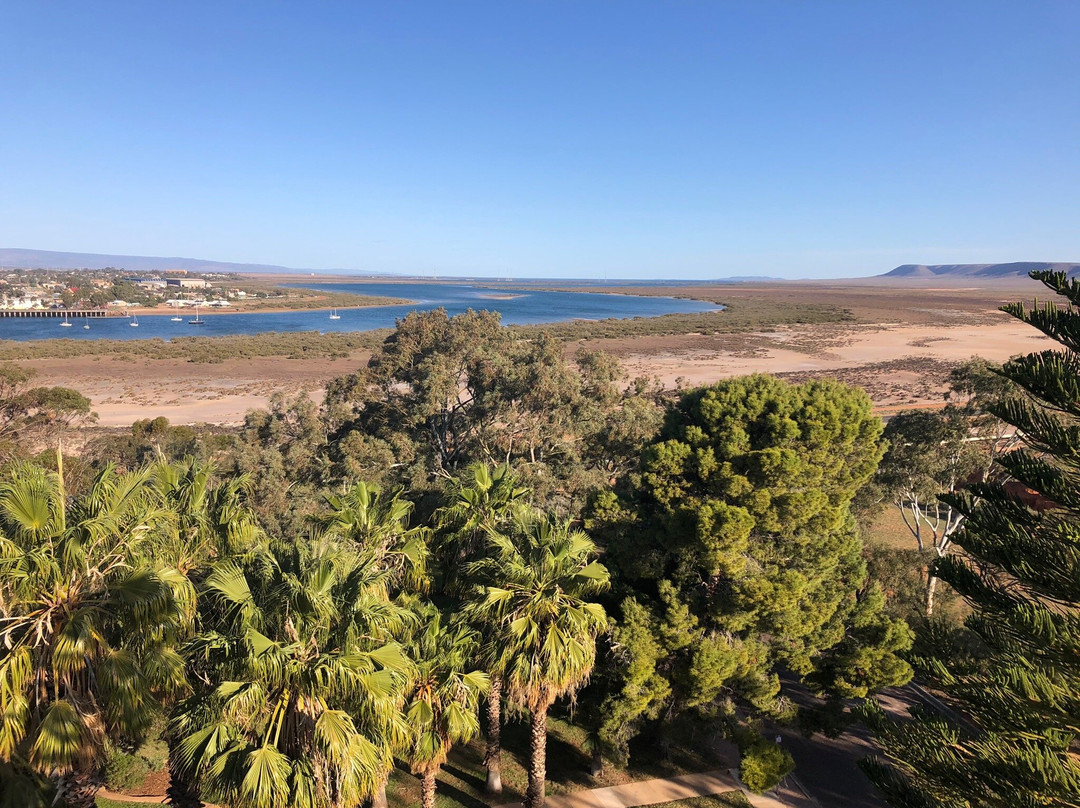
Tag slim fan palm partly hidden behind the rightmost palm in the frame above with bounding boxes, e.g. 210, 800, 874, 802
437, 463, 529, 794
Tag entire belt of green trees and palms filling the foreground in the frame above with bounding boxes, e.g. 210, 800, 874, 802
0, 275, 1067, 808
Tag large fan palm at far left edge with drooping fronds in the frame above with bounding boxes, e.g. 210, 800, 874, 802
0, 454, 187, 808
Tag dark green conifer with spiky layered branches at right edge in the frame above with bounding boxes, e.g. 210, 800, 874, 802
864, 271, 1080, 808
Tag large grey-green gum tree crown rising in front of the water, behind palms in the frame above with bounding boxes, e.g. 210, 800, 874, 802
324, 309, 661, 512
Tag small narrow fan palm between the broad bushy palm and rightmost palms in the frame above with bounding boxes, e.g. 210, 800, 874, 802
404, 607, 488, 808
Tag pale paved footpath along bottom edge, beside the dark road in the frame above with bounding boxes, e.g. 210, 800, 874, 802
501, 769, 816, 808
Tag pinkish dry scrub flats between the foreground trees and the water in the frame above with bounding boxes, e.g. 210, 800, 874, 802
21, 280, 1050, 427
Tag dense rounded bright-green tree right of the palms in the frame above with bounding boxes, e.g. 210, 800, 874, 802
588, 376, 912, 758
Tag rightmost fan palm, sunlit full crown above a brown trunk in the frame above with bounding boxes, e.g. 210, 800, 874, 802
465, 514, 608, 808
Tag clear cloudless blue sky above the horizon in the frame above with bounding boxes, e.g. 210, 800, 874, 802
0, 0, 1080, 279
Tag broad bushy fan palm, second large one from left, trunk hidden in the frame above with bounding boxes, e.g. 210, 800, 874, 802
175, 529, 413, 808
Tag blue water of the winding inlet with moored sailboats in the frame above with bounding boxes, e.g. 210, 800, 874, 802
0, 283, 718, 340
